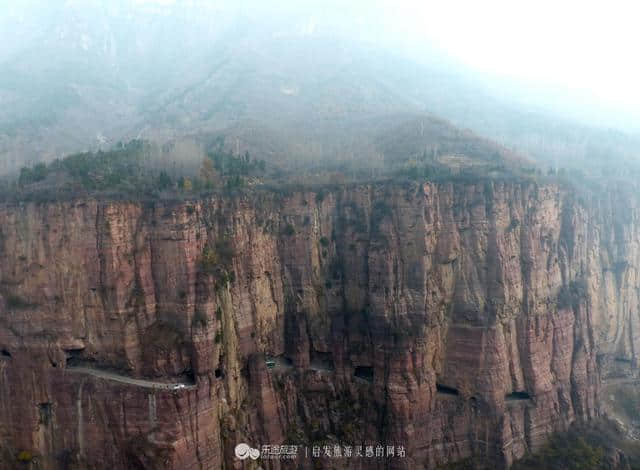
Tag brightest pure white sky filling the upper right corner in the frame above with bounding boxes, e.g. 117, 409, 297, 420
388, 0, 640, 124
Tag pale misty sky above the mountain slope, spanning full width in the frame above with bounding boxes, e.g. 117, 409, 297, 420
0, 0, 640, 130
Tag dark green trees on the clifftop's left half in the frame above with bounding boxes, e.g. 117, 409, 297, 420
8, 139, 267, 200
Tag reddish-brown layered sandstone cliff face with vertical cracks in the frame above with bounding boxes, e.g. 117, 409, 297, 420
0, 183, 640, 469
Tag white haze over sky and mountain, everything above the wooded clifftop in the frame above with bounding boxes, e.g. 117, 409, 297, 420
0, 0, 640, 175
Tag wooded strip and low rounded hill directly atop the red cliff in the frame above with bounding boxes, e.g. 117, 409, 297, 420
7, 115, 640, 201
